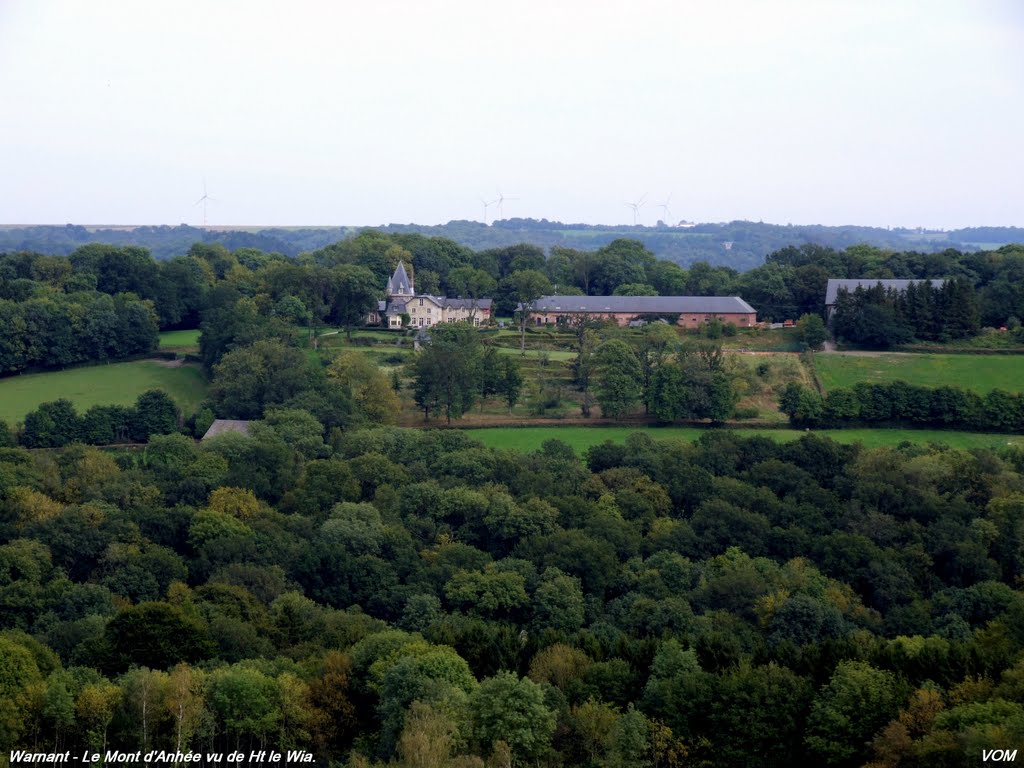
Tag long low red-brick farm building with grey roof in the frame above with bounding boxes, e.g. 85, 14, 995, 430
529, 296, 758, 328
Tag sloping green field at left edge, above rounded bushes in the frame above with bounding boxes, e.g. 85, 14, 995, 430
0, 360, 207, 424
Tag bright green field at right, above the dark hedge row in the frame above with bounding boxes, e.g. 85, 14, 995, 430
814, 353, 1024, 394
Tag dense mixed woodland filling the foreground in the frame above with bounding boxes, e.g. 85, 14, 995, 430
0, 430, 1024, 766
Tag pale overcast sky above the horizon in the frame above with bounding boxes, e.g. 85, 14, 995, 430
0, 0, 1024, 228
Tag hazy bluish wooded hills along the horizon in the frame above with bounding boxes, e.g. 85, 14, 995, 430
0, 219, 1024, 270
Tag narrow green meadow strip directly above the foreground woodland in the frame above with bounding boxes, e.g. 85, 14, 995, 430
466, 427, 1024, 454
